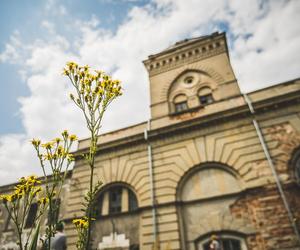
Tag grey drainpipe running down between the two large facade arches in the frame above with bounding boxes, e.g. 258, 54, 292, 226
144, 120, 157, 245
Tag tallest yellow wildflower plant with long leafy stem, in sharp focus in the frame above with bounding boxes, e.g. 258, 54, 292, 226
63, 62, 122, 250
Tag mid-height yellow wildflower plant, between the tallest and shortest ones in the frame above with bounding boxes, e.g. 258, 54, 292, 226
31, 130, 77, 249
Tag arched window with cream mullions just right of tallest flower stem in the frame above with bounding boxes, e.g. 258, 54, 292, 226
95, 185, 138, 216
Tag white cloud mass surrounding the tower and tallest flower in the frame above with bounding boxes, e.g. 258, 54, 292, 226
0, 0, 300, 183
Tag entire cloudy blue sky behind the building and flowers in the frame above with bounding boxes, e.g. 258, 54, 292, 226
0, 0, 300, 185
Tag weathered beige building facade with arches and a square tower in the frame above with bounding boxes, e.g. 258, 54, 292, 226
0, 33, 300, 250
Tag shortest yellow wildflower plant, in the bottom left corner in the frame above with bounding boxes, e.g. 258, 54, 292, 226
0, 175, 48, 250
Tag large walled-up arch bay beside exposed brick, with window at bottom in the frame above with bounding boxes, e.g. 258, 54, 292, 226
177, 162, 252, 250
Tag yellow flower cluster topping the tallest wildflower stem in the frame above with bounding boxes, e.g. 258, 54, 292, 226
63, 62, 122, 112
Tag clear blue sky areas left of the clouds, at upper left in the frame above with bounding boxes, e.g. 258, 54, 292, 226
0, 0, 147, 134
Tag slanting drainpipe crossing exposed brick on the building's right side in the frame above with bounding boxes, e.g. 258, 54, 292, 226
244, 94, 300, 242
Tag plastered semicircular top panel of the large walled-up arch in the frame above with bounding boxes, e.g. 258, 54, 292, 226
176, 162, 243, 201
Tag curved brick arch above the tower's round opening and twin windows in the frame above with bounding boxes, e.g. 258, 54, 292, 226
160, 65, 224, 101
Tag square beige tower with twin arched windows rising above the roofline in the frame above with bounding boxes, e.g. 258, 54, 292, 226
144, 32, 241, 120
